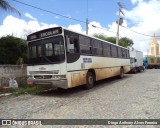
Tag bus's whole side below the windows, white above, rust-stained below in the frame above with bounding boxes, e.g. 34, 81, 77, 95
67, 55, 130, 88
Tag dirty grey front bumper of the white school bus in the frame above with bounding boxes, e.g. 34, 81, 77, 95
27, 79, 68, 89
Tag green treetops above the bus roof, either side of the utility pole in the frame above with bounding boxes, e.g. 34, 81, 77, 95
94, 34, 134, 47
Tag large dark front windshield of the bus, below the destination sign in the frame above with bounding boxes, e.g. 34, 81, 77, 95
28, 36, 65, 65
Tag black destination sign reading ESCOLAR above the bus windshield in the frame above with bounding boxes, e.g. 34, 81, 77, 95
27, 27, 62, 41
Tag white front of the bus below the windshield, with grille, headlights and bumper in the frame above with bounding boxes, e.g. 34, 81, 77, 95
27, 63, 68, 89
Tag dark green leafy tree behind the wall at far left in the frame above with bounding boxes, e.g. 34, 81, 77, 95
0, 36, 28, 64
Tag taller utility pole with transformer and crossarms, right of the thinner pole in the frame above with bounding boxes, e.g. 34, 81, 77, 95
116, 2, 124, 45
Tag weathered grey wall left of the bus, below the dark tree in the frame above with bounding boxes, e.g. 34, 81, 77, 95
0, 65, 27, 87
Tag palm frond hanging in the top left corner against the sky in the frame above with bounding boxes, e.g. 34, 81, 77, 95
0, 0, 21, 15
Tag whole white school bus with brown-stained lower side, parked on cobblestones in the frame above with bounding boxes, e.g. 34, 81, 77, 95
27, 27, 130, 89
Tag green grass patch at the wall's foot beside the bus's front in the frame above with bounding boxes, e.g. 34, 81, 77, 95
9, 85, 44, 95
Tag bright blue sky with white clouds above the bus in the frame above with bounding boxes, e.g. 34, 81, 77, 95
0, 0, 160, 52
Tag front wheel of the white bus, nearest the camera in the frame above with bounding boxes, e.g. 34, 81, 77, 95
85, 72, 95, 89
